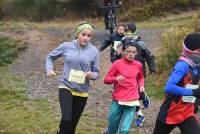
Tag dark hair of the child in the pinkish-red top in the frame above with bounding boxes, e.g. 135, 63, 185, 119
122, 37, 138, 50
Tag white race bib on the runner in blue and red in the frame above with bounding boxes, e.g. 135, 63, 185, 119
182, 84, 198, 103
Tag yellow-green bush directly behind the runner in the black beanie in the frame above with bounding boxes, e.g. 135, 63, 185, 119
158, 14, 200, 72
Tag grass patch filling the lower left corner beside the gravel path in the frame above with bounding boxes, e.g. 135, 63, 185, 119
0, 67, 59, 134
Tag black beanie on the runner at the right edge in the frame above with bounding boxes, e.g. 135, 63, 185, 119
184, 33, 200, 51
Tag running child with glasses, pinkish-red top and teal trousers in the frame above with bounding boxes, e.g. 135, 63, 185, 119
104, 40, 144, 134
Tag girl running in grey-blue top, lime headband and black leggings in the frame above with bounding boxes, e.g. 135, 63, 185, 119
46, 22, 99, 134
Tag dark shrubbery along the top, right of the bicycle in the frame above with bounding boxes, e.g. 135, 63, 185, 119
120, 0, 200, 21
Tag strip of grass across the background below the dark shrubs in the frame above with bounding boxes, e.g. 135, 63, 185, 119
0, 11, 195, 32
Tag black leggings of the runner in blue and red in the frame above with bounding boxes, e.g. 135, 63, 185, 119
153, 116, 200, 134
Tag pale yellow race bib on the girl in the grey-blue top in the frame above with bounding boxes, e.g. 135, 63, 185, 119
68, 69, 86, 84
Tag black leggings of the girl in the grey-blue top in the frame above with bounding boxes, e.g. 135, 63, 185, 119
59, 88, 87, 134
